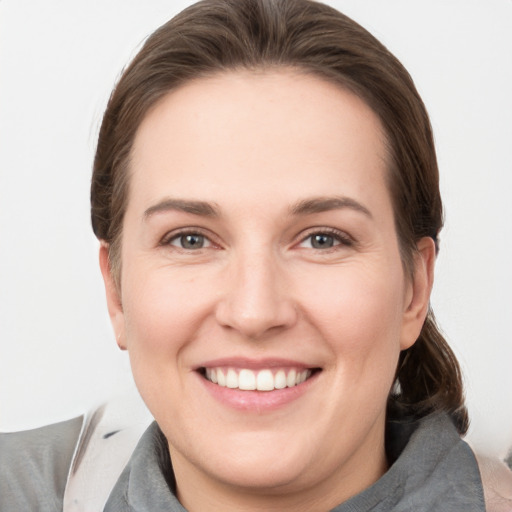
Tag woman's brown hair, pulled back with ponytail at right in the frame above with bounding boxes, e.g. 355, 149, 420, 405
91, 0, 468, 433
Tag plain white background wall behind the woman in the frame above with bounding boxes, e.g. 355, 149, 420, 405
0, 0, 512, 454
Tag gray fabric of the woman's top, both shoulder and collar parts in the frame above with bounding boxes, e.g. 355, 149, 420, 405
0, 414, 485, 512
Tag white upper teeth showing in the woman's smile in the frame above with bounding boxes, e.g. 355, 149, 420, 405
205, 368, 311, 391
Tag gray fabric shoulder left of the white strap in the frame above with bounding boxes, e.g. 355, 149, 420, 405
0, 417, 83, 512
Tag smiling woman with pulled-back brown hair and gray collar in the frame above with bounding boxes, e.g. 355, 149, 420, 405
2, 0, 508, 512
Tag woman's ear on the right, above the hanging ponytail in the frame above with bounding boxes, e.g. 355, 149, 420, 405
400, 237, 436, 350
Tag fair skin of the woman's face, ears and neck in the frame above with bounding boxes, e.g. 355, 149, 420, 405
100, 70, 435, 512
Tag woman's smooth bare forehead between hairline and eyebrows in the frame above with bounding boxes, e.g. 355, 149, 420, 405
129, 70, 387, 213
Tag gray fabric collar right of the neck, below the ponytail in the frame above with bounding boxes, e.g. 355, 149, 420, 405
332, 414, 485, 512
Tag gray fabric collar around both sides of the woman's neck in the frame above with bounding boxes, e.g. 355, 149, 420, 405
105, 414, 485, 512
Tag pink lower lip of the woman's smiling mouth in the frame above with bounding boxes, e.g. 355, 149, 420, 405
198, 372, 320, 413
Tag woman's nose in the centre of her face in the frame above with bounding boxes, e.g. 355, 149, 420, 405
216, 252, 298, 340
